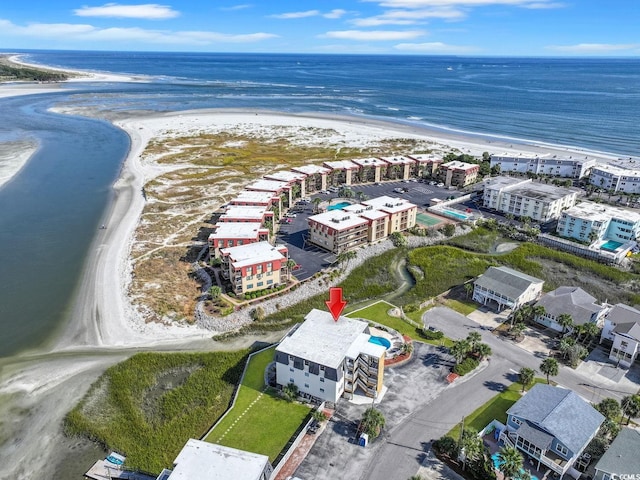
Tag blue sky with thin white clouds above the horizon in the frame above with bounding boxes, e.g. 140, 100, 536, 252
0, 0, 640, 57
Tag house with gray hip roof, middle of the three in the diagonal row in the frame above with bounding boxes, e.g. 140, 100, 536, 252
534, 287, 607, 332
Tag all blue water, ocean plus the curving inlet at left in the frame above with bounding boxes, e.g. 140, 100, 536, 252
0, 51, 640, 357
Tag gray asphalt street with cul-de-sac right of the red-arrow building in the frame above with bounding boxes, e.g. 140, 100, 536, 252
360, 308, 637, 480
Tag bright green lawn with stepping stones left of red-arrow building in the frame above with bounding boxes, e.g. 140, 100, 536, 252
205, 346, 310, 462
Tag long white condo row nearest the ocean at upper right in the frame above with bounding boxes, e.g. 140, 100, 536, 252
491, 153, 596, 178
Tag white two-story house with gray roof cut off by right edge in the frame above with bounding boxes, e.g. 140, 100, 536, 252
600, 303, 640, 368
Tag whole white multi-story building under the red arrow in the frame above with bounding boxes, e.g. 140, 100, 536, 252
275, 309, 390, 402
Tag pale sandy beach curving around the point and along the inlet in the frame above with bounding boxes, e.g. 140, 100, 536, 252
0, 60, 632, 478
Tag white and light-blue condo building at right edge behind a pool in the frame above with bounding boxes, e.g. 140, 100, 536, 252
557, 202, 640, 244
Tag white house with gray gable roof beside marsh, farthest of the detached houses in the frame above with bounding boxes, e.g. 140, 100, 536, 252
473, 267, 544, 311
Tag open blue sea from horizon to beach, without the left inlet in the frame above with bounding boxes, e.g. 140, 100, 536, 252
11, 52, 640, 156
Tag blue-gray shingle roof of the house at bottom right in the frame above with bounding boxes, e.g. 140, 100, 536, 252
507, 383, 604, 453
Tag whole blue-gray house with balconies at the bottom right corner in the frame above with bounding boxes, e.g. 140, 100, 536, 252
500, 383, 604, 478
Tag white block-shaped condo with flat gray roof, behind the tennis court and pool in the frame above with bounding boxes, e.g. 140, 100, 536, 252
482, 177, 578, 223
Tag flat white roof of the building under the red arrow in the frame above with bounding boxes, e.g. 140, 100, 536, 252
276, 308, 369, 368
